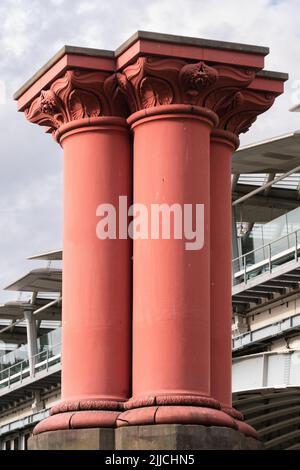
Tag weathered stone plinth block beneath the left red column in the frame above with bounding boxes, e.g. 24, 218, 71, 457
28, 428, 115, 450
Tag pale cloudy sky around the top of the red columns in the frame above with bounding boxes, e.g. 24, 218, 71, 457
0, 0, 300, 301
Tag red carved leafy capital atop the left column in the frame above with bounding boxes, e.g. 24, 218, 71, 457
25, 70, 126, 132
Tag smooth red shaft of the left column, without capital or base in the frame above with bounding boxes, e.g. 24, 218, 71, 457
59, 118, 131, 401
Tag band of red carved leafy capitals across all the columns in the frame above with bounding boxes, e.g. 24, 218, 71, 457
25, 57, 275, 139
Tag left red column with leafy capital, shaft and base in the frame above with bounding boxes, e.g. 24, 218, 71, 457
17, 65, 132, 434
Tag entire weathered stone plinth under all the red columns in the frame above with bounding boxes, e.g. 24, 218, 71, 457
28, 424, 263, 450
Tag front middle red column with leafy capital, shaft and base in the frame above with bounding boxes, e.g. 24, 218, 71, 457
113, 57, 255, 428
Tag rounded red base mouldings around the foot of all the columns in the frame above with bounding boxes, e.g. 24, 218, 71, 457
33, 396, 258, 439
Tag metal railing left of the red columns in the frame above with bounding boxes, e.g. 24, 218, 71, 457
0, 344, 61, 390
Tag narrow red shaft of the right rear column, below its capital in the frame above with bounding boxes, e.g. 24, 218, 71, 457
210, 129, 239, 412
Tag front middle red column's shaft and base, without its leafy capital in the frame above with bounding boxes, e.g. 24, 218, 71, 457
118, 105, 235, 427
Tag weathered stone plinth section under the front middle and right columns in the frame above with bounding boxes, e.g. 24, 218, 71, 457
115, 424, 263, 450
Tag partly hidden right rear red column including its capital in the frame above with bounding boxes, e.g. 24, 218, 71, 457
210, 72, 286, 430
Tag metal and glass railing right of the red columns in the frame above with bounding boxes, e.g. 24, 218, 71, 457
232, 230, 300, 285
